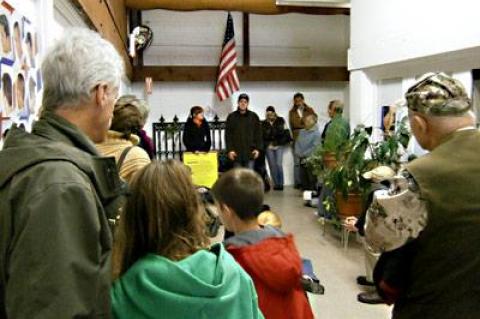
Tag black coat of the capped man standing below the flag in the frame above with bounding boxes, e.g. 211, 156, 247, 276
225, 110, 263, 161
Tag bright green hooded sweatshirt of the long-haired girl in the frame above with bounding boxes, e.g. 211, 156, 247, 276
111, 244, 263, 319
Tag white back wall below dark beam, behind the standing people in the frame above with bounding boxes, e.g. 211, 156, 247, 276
132, 82, 349, 184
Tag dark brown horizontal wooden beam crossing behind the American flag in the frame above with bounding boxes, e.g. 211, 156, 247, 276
133, 66, 349, 82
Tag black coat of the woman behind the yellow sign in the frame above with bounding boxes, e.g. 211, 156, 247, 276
183, 117, 212, 152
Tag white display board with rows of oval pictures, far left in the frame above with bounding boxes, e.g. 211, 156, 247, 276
0, 1, 42, 140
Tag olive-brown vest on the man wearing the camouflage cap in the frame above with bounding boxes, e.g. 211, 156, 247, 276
393, 129, 480, 319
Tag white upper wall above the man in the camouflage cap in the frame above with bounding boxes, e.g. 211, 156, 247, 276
348, 0, 480, 136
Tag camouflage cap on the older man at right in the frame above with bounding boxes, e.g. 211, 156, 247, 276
405, 73, 472, 116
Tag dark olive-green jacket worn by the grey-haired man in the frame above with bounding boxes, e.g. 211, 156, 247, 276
0, 114, 123, 319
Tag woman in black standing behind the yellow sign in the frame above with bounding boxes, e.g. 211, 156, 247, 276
183, 106, 212, 152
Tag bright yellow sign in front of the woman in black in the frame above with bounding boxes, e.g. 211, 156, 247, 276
183, 152, 218, 188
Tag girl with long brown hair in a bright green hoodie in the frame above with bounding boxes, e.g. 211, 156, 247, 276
110, 160, 263, 319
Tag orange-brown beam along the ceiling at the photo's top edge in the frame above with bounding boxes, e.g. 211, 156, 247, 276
126, 0, 350, 15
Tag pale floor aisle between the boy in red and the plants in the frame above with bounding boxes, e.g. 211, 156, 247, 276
266, 188, 391, 319
